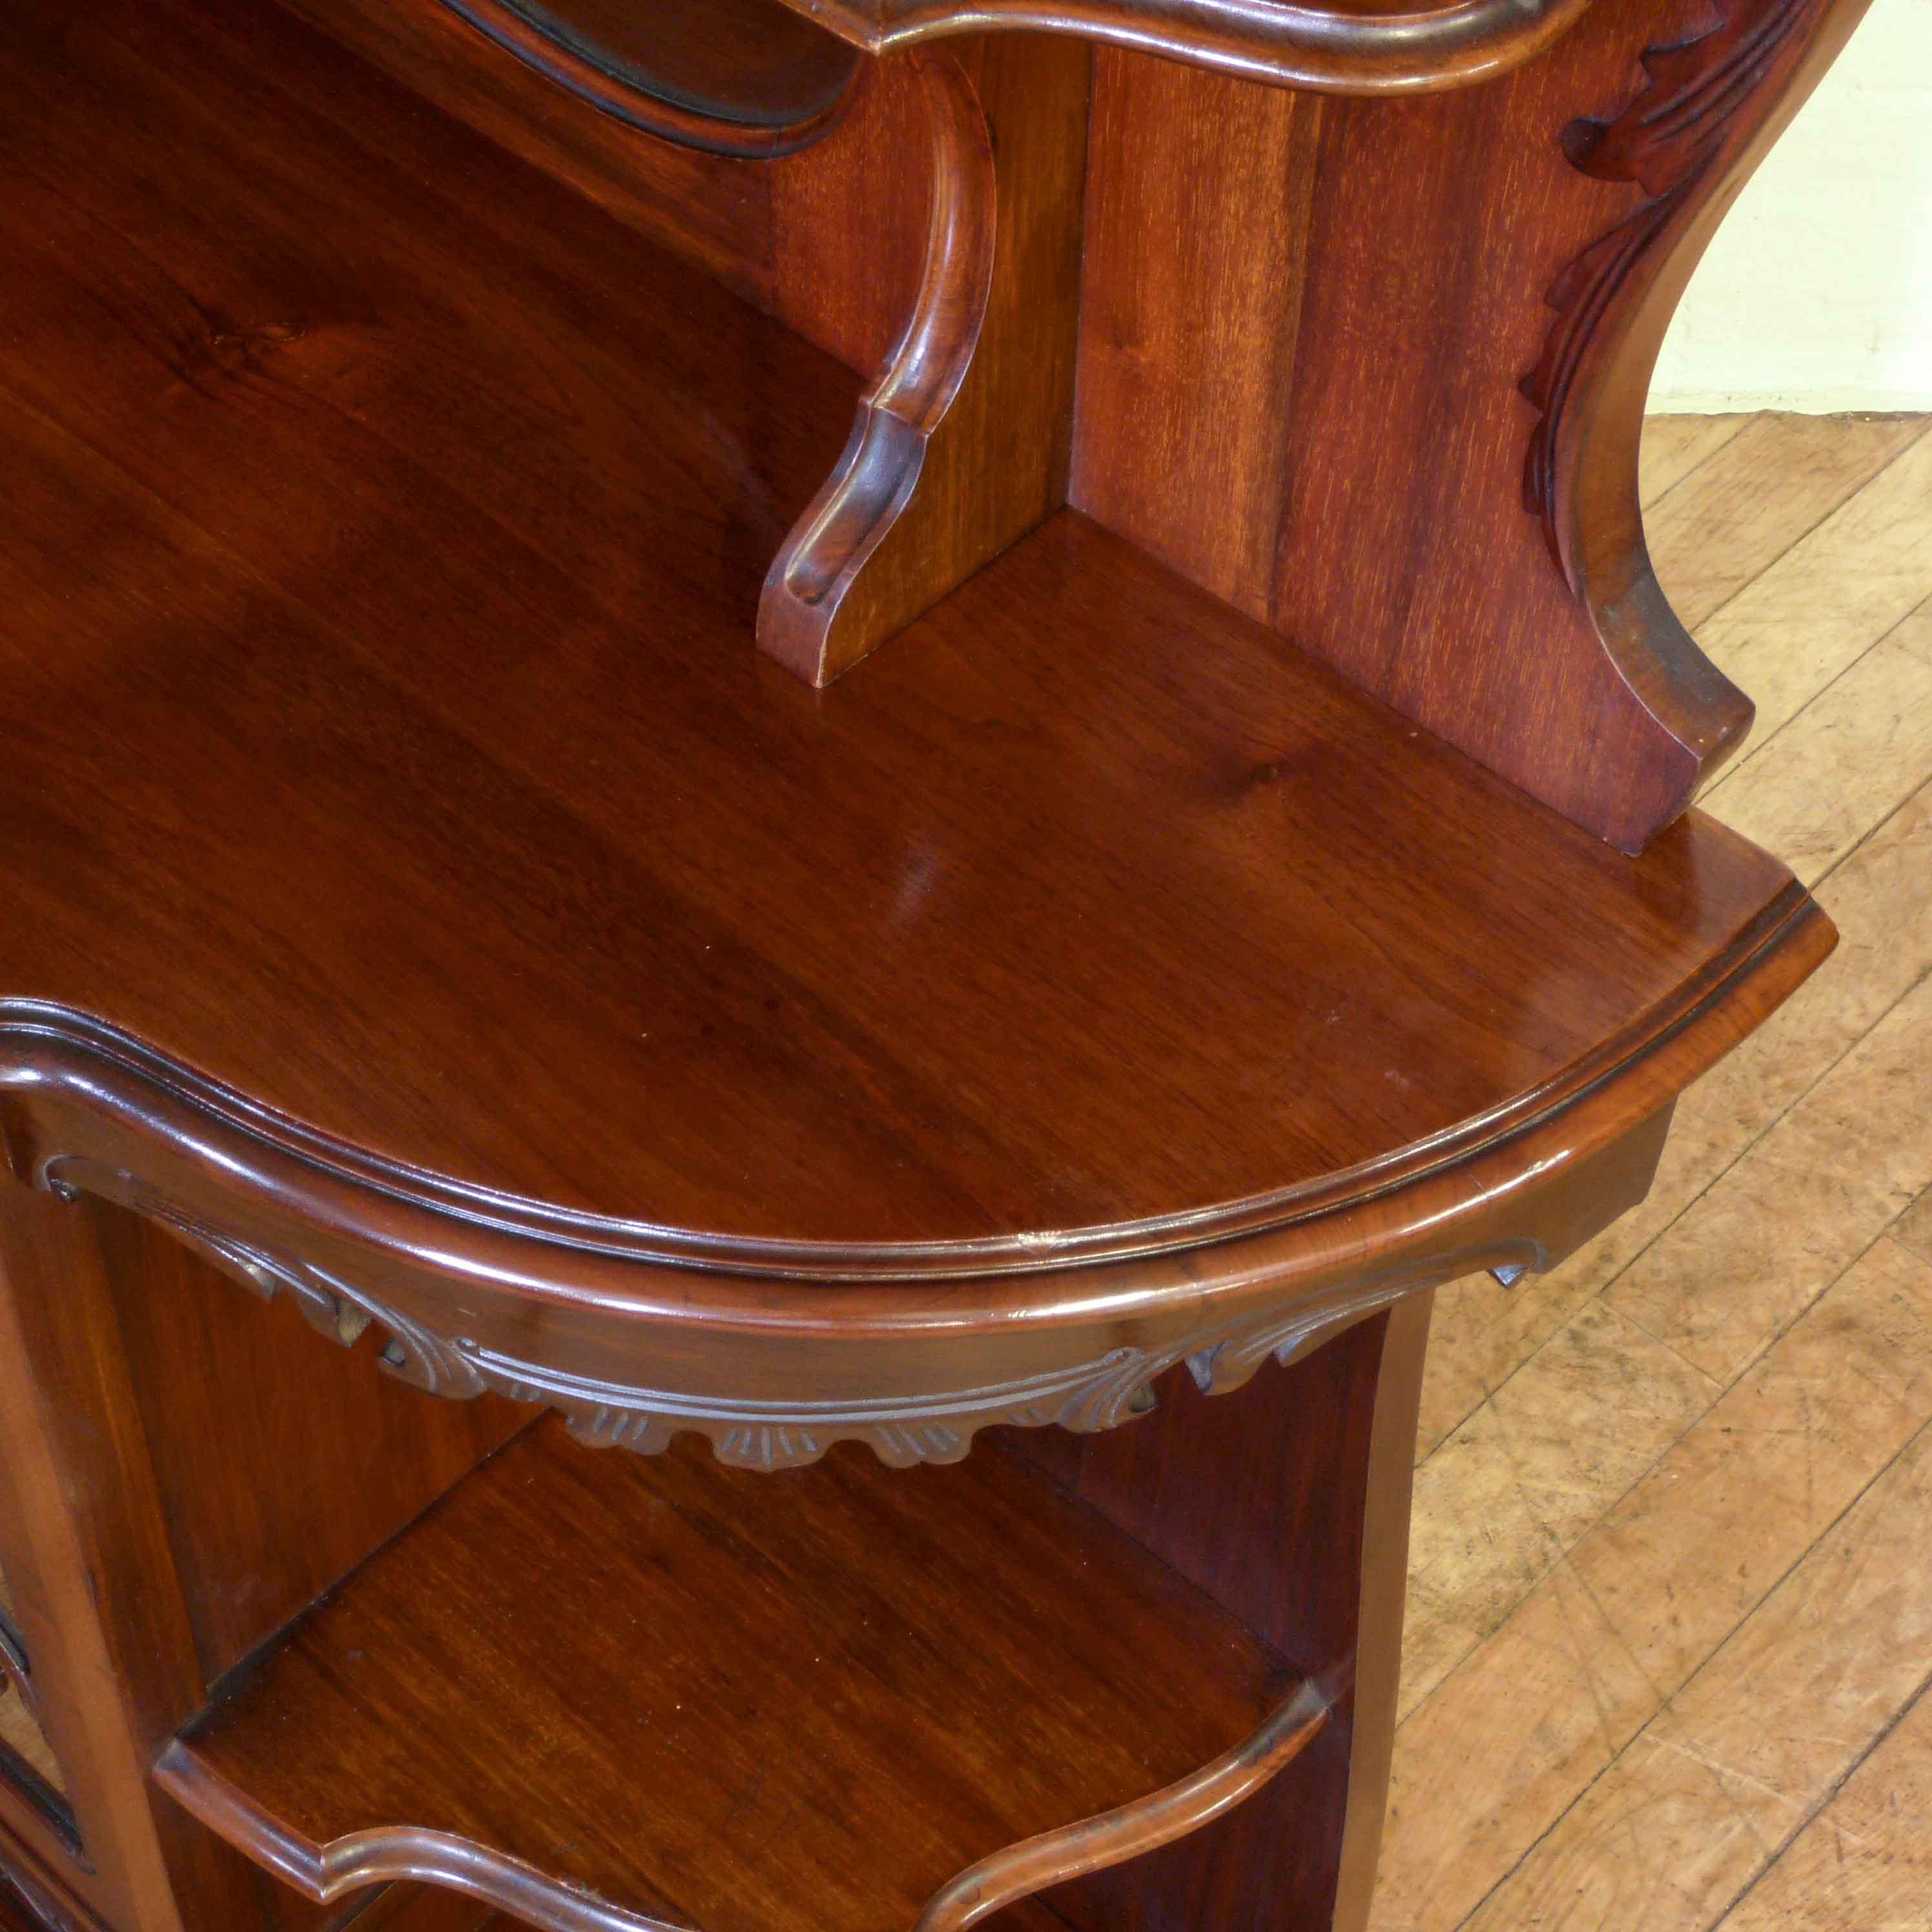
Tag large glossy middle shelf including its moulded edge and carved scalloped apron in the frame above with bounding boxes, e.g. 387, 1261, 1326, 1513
0, 0, 1829, 1464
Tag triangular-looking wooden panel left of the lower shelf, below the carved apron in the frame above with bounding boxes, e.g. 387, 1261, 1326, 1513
99, 1208, 529, 1683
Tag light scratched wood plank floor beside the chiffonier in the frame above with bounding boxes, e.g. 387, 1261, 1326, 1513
1373, 415, 1932, 1932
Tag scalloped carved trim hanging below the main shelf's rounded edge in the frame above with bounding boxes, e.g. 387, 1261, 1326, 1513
43, 1157, 1441, 1470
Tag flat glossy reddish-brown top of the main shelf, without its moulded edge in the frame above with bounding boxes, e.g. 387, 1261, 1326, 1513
0, 0, 1816, 1252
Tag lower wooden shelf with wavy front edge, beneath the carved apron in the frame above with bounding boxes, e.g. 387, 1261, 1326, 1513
156, 1422, 1328, 1932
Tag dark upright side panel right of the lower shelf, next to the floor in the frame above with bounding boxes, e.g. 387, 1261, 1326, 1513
1012, 1293, 1434, 1932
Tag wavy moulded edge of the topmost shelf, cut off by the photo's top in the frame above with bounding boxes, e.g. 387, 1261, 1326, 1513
786, 0, 1590, 95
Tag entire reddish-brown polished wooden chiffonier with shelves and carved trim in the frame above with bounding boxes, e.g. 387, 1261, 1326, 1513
0, 0, 1886, 1932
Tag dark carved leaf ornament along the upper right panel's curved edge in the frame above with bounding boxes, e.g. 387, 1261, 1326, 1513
1521, 0, 1816, 579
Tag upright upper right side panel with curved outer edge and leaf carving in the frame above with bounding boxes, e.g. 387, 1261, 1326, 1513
1073, 0, 1858, 850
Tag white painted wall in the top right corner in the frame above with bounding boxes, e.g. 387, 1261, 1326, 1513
1650, 0, 1932, 411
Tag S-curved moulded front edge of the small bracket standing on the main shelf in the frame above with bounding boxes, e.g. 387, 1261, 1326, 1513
757, 54, 999, 684
